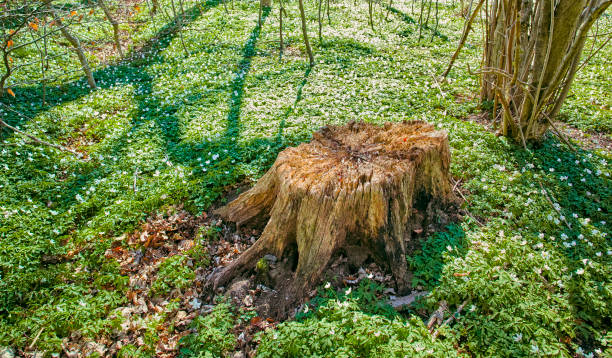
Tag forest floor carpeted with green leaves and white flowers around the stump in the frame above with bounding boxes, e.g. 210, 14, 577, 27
0, 0, 612, 357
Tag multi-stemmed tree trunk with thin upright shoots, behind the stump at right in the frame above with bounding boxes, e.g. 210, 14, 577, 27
481, 0, 612, 144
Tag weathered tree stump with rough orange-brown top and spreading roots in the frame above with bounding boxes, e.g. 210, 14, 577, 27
212, 121, 454, 312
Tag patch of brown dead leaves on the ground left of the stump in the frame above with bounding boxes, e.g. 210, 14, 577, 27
63, 207, 206, 357
